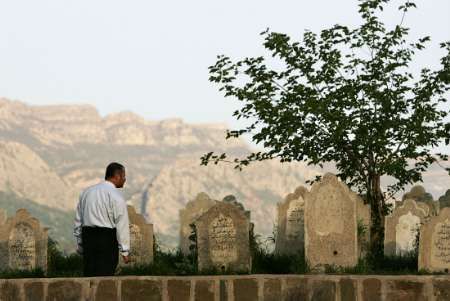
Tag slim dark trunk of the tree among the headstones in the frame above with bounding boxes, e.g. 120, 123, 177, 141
367, 174, 385, 257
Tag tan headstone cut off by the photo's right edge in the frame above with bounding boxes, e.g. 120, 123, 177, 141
419, 207, 450, 273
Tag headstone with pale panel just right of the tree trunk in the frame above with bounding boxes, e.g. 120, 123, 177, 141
384, 199, 429, 256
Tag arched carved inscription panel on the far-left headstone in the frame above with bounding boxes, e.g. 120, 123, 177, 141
9, 223, 36, 270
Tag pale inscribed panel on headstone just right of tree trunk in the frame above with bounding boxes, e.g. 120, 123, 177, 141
395, 211, 420, 255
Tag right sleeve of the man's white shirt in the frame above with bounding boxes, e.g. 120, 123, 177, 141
113, 193, 130, 256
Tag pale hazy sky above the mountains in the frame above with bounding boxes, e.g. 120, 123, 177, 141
0, 0, 450, 126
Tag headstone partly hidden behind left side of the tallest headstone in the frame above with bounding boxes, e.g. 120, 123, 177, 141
275, 186, 308, 254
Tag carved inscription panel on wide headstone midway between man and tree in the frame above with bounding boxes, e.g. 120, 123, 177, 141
209, 214, 237, 264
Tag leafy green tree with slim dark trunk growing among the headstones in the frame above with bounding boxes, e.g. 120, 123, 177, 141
201, 0, 450, 254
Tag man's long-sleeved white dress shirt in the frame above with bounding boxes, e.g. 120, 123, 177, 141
74, 181, 130, 256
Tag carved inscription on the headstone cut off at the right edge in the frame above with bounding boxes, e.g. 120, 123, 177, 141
431, 220, 450, 266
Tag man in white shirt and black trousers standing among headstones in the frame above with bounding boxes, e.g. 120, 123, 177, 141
74, 162, 130, 277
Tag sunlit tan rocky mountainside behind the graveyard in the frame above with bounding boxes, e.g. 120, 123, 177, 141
0, 98, 450, 247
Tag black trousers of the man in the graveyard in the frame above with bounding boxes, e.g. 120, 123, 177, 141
81, 227, 119, 277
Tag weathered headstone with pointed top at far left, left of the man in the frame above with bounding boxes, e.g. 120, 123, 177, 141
0, 209, 48, 272
